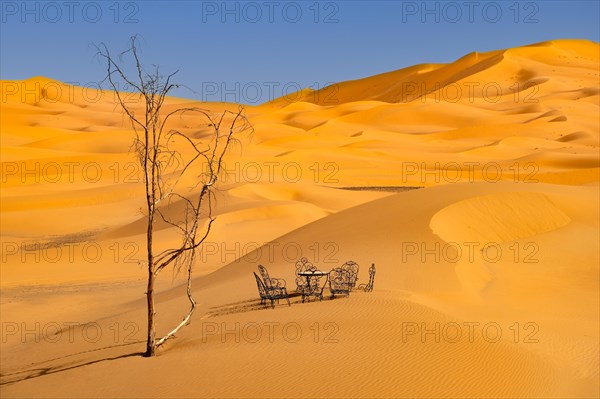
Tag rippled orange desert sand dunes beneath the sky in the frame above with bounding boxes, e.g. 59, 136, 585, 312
0, 40, 600, 398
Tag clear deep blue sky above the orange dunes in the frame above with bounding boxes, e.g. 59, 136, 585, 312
0, 0, 600, 103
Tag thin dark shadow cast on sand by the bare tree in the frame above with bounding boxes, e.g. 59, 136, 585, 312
0, 341, 145, 386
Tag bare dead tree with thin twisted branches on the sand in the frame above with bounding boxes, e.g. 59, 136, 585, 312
98, 36, 251, 356
